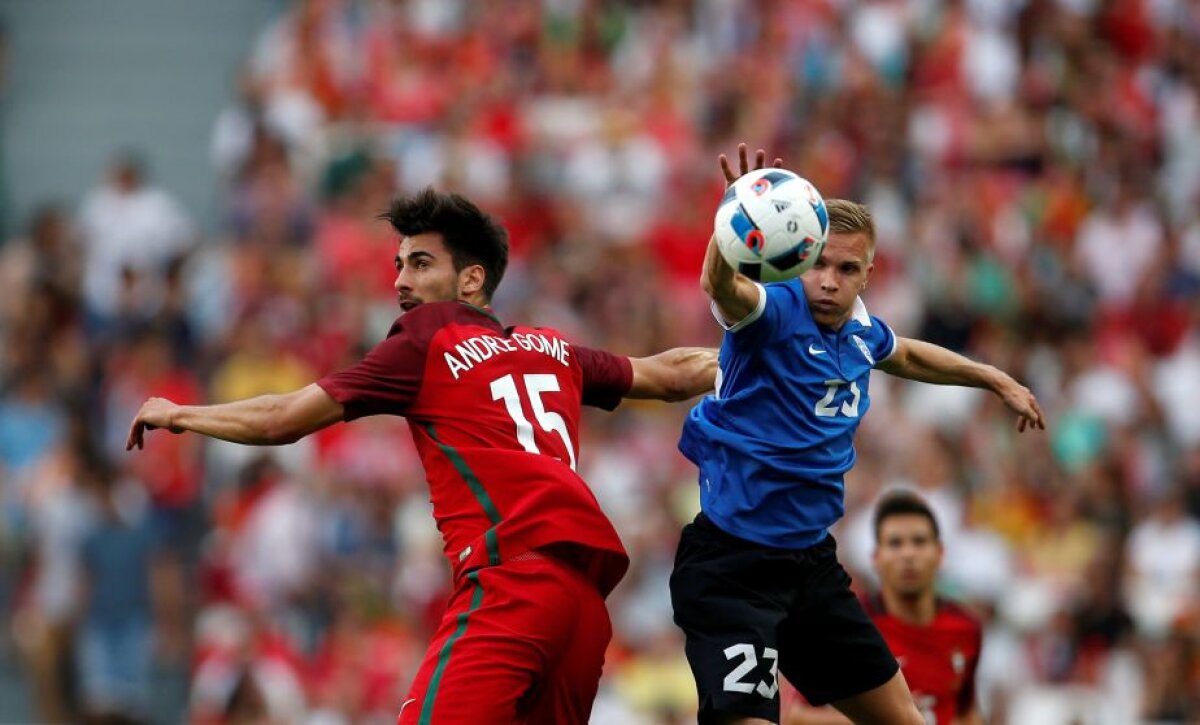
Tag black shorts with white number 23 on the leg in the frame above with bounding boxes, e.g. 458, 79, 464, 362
671, 514, 899, 724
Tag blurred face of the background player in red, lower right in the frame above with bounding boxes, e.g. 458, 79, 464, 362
875, 514, 942, 597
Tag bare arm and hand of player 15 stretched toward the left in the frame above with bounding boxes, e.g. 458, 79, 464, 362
125, 383, 343, 450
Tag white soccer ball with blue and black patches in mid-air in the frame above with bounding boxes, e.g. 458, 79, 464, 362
715, 168, 829, 282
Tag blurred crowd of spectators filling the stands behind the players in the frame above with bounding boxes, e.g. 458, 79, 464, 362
0, 0, 1200, 725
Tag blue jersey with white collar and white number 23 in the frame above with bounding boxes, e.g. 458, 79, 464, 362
679, 280, 896, 549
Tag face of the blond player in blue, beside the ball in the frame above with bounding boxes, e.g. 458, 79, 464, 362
800, 232, 874, 329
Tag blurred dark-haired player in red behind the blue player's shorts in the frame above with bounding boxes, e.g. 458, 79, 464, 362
786, 490, 983, 725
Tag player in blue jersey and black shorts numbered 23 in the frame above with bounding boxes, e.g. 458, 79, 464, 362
671, 145, 1044, 725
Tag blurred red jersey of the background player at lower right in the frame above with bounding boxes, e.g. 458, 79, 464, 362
865, 597, 983, 725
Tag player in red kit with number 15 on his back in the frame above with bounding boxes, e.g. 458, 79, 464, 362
126, 190, 716, 724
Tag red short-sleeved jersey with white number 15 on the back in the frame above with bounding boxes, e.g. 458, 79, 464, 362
318, 302, 632, 594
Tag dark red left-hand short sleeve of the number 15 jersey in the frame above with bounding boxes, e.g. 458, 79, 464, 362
317, 307, 430, 420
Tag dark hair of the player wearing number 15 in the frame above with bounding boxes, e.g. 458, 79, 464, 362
379, 186, 509, 300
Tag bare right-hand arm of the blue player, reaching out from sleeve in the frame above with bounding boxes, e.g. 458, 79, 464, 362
878, 336, 1046, 431
